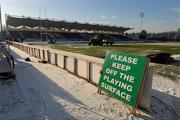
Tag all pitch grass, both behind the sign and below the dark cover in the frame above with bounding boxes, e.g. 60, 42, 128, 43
35, 43, 180, 82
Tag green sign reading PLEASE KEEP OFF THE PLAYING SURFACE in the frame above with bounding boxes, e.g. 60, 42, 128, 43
98, 52, 148, 107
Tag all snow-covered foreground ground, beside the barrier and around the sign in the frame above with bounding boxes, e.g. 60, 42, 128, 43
0, 47, 180, 120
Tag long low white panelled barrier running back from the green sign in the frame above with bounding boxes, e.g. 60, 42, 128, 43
9, 42, 104, 85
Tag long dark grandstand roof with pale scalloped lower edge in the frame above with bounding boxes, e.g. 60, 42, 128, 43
6, 15, 130, 34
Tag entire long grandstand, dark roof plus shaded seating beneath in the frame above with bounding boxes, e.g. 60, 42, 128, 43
6, 14, 131, 41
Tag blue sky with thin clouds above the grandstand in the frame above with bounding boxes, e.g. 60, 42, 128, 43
0, 0, 180, 32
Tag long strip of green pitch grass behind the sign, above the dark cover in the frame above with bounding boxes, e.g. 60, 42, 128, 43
40, 44, 180, 58
